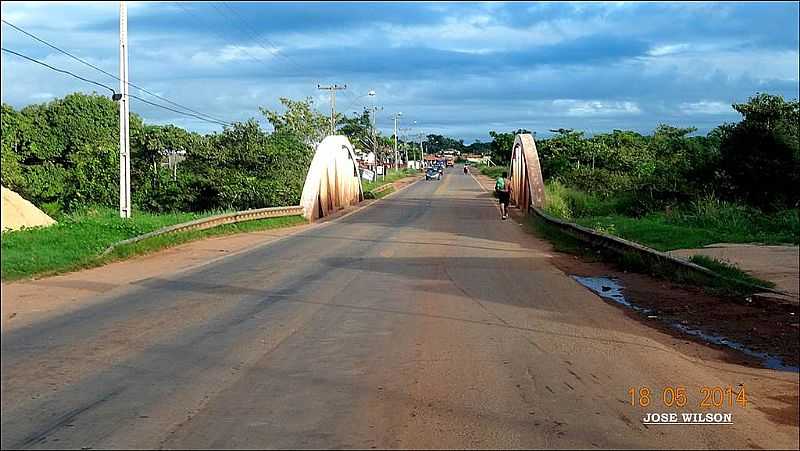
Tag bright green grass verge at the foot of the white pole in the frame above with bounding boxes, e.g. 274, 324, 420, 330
0, 208, 304, 281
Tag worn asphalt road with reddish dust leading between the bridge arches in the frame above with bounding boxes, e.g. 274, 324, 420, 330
2, 167, 798, 449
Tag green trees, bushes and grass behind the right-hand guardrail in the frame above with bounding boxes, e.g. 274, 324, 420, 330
483, 94, 800, 250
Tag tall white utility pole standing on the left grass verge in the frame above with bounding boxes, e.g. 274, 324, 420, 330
119, 1, 131, 218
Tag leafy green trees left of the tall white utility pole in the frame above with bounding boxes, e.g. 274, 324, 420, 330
1, 94, 142, 212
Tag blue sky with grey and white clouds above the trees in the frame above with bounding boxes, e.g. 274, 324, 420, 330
0, 1, 800, 144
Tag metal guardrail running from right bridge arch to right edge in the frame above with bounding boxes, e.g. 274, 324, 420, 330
530, 206, 794, 298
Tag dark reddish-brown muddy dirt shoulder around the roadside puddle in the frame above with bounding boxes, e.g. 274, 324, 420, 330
475, 174, 800, 368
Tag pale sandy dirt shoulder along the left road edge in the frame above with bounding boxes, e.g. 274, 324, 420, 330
2, 177, 419, 332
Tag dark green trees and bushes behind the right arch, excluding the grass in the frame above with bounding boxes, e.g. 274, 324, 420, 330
528, 94, 800, 216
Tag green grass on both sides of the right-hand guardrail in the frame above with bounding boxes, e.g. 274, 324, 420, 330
531, 182, 800, 296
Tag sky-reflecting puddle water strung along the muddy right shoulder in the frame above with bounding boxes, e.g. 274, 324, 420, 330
571, 276, 800, 373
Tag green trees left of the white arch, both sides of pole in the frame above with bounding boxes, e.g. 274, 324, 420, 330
2, 93, 329, 215
